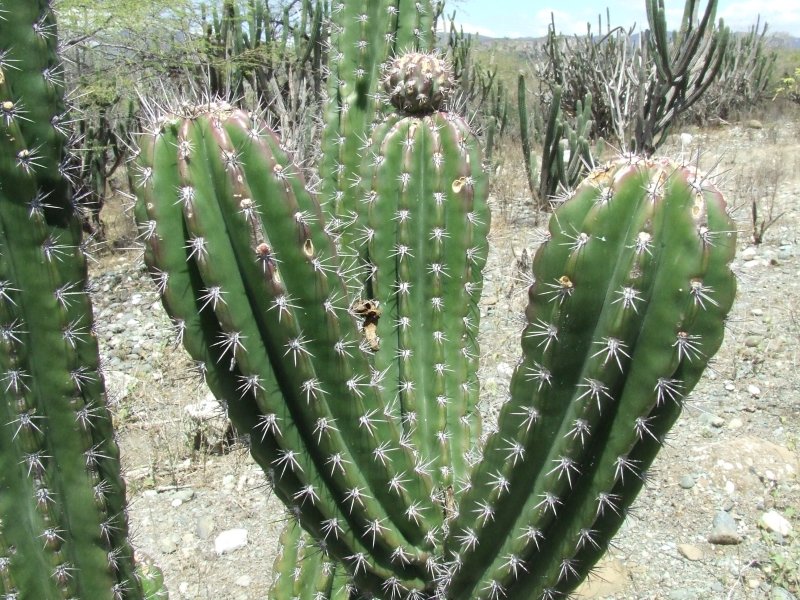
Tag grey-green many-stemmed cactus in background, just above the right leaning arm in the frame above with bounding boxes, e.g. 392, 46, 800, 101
539, 0, 732, 155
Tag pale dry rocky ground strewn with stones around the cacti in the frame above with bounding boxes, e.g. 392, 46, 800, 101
92, 116, 800, 600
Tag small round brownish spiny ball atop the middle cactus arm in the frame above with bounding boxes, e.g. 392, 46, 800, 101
383, 52, 453, 115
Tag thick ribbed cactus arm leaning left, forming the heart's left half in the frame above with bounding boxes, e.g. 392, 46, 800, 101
137, 105, 454, 589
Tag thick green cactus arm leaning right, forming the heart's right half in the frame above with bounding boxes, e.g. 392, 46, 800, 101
450, 157, 735, 598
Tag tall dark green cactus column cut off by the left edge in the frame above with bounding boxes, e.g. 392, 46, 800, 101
0, 0, 151, 600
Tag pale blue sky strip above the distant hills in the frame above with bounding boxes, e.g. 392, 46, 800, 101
448, 0, 800, 37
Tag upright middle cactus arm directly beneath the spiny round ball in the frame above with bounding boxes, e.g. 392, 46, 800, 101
365, 115, 488, 488
